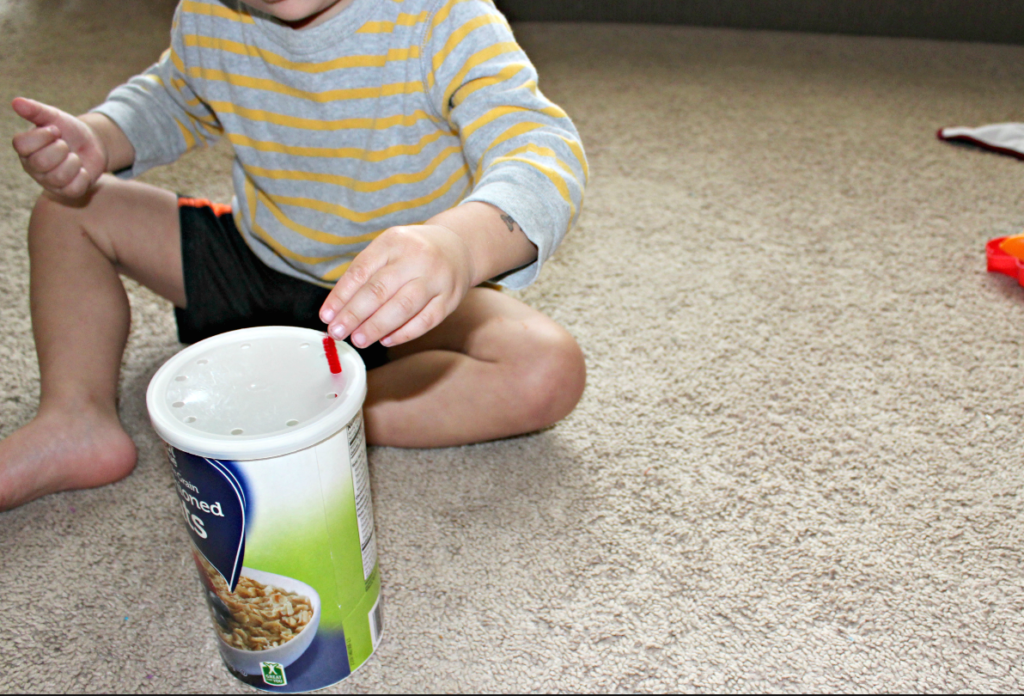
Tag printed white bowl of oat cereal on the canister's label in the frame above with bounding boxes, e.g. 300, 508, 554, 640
197, 555, 321, 675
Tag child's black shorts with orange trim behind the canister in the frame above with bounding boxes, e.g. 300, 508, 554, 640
174, 198, 387, 369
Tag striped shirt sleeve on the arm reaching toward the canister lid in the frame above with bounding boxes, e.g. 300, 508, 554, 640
422, 0, 589, 289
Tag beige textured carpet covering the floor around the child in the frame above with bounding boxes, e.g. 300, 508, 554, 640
6, 0, 1024, 693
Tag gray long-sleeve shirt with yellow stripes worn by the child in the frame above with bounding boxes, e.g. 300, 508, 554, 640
95, 0, 588, 288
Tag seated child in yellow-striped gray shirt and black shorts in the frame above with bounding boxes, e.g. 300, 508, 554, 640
0, 0, 588, 509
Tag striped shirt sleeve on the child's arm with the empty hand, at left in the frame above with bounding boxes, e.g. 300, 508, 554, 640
92, 6, 223, 178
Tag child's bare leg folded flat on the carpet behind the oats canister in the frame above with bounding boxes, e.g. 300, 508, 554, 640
365, 289, 586, 447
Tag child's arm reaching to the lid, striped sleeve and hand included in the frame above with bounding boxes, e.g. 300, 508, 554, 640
321, 2, 588, 347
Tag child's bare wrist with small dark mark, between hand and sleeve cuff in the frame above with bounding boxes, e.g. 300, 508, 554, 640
426, 201, 537, 286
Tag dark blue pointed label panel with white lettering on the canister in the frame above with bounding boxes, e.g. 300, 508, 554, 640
168, 447, 249, 592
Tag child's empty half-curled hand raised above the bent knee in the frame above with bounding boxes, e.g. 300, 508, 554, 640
11, 97, 108, 199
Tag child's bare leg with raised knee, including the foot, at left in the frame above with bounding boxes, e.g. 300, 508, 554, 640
0, 176, 184, 510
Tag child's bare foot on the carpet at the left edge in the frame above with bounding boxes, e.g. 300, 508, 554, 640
0, 408, 136, 510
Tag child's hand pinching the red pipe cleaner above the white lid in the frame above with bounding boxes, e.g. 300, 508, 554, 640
319, 224, 474, 348
